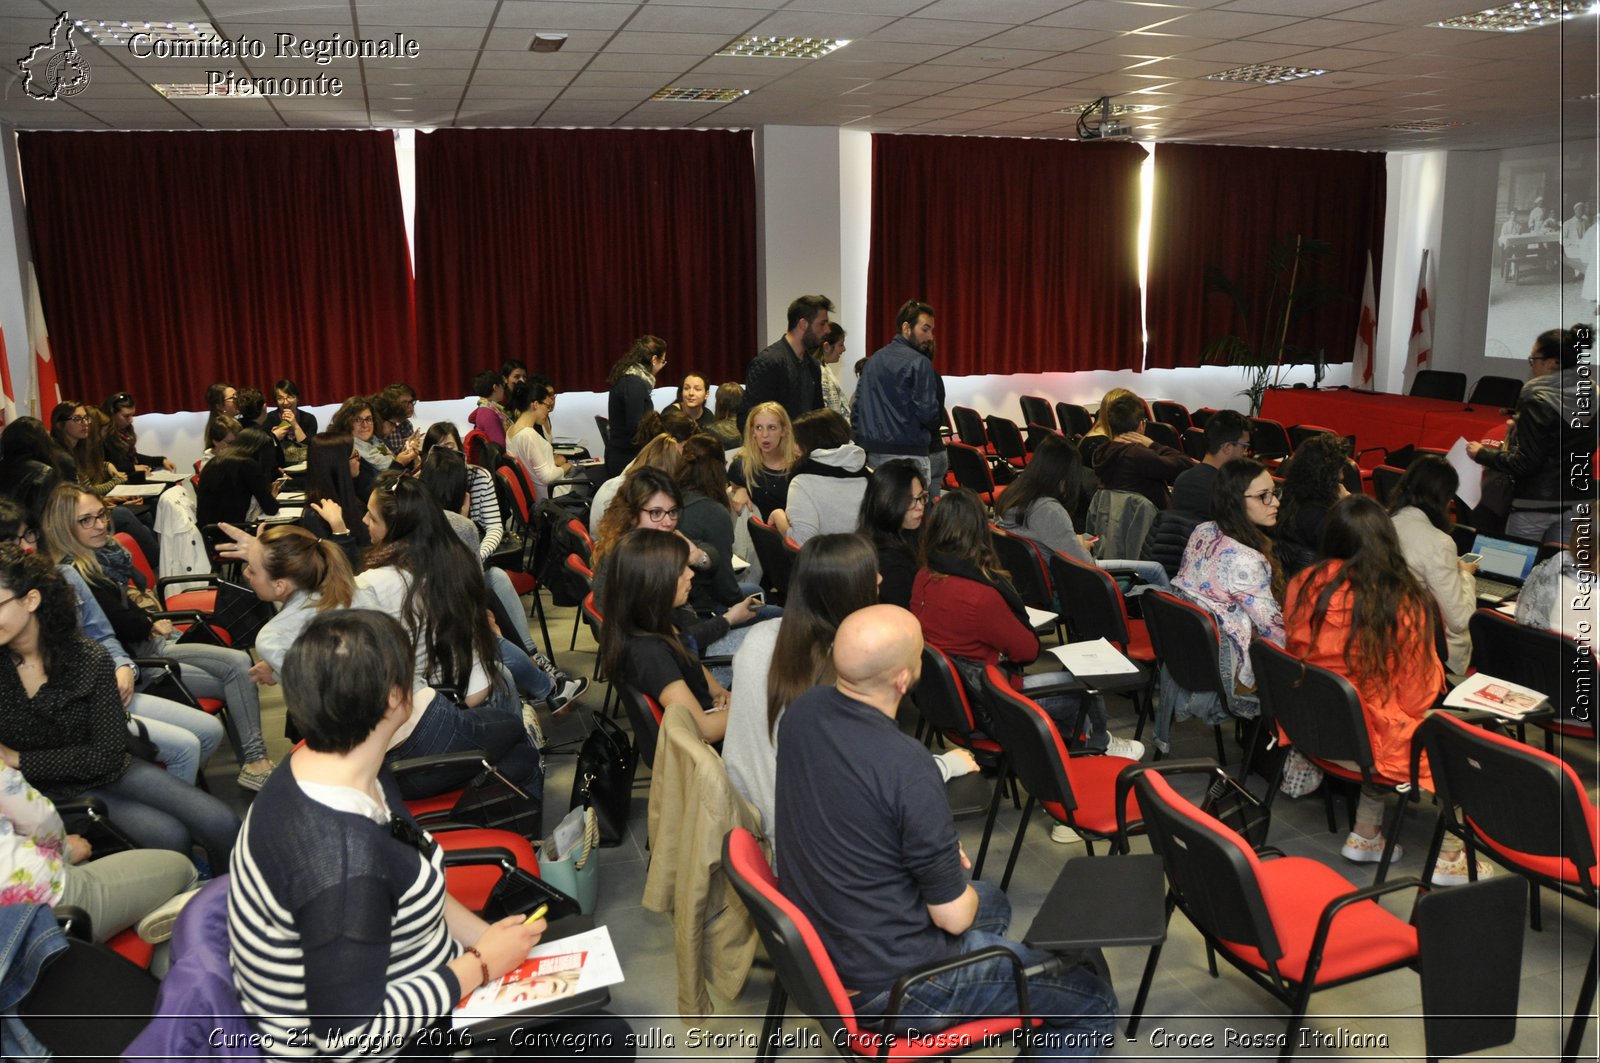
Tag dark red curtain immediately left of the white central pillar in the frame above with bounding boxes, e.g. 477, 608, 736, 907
416, 130, 758, 391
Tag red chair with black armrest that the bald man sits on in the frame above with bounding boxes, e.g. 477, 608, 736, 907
722, 828, 1038, 1063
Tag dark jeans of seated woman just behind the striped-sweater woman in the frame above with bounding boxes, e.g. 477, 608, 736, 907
384, 690, 544, 800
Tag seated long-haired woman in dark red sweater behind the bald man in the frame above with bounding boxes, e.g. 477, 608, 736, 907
910, 488, 1144, 760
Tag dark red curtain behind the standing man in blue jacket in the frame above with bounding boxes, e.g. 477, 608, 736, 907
861, 134, 1146, 376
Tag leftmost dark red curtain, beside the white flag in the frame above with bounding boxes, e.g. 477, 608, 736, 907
18, 131, 412, 410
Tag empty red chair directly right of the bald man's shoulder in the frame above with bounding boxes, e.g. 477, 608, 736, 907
984, 664, 1139, 890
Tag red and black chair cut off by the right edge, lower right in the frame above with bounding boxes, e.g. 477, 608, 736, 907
1411, 712, 1600, 1061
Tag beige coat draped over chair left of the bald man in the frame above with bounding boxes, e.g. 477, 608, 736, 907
643, 704, 762, 1018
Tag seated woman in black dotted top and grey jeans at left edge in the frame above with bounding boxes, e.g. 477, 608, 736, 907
0, 544, 238, 868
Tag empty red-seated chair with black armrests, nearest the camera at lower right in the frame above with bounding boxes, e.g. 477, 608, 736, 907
1128, 762, 1421, 1058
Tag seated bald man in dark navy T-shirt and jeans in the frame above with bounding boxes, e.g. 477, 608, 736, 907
776, 605, 1117, 1060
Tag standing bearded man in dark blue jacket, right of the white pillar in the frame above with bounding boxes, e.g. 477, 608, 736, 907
850, 299, 939, 490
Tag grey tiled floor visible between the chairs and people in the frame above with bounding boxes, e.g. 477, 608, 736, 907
246, 598, 1597, 1060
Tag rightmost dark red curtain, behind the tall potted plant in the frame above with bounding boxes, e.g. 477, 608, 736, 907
1146, 144, 1387, 368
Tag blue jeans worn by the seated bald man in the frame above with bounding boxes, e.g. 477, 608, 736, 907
856, 882, 1117, 1060
